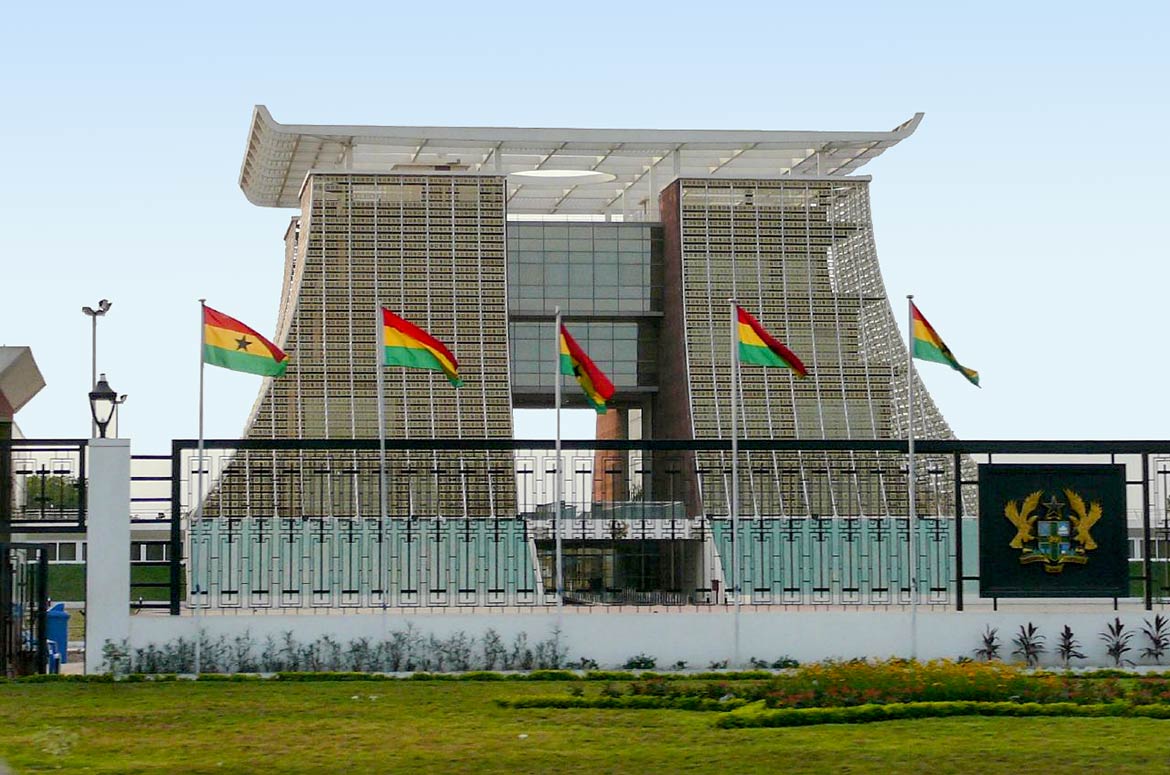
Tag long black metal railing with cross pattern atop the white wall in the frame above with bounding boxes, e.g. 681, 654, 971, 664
160, 439, 1170, 613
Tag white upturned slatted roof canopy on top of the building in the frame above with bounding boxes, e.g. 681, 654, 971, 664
240, 105, 922, 215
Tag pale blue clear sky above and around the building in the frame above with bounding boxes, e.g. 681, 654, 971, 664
0, 1, 1170, 454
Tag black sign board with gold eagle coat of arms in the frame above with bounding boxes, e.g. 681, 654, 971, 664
979, 465, 1129, 597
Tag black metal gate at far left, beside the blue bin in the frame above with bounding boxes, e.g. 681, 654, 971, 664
0, 543, 49, 678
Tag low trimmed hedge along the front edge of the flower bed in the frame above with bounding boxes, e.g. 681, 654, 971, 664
715, 701, 1170, 729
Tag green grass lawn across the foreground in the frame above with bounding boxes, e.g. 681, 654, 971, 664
0, 681, 1170, 775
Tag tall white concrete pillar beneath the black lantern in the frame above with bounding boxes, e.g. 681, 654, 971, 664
85, 439, 130, 674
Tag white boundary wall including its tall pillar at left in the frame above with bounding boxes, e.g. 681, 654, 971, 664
85, 439, 1165, 673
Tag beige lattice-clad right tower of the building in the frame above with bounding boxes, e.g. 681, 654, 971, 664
659, 178, 952, 516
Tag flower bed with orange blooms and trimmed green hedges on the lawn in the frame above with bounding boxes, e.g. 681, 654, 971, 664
498, 659, 1170, 727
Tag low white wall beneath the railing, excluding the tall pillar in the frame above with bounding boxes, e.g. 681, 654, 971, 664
123, 606, 1154, 668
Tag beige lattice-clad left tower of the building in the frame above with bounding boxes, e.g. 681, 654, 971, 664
216, 174, 515, 517
